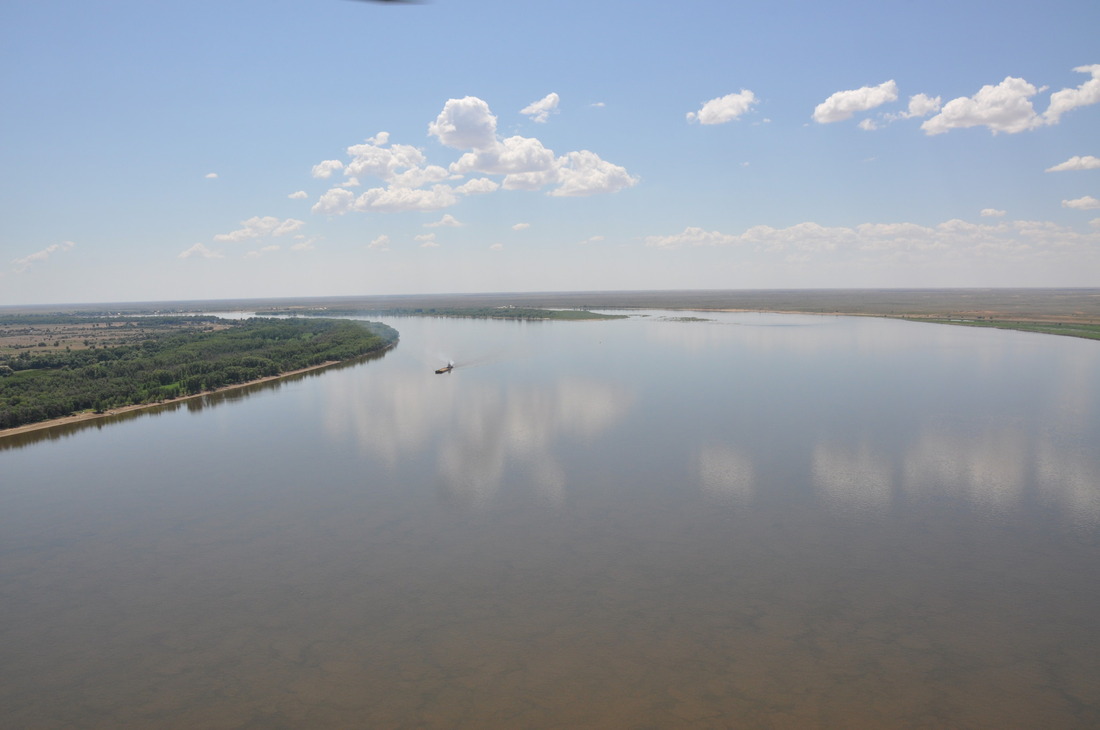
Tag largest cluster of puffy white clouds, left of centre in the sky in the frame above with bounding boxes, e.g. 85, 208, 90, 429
312, 93, 637, 214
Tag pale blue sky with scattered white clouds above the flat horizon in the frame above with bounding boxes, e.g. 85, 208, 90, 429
0, 0, 1100, 305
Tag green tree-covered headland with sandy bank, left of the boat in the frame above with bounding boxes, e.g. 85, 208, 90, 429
0, 316, 398, 430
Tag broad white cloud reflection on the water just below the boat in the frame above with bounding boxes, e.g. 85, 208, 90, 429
326, 373, 633, 505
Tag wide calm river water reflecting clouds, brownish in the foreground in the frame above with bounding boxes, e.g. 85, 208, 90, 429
0, 312, 1100, 729
